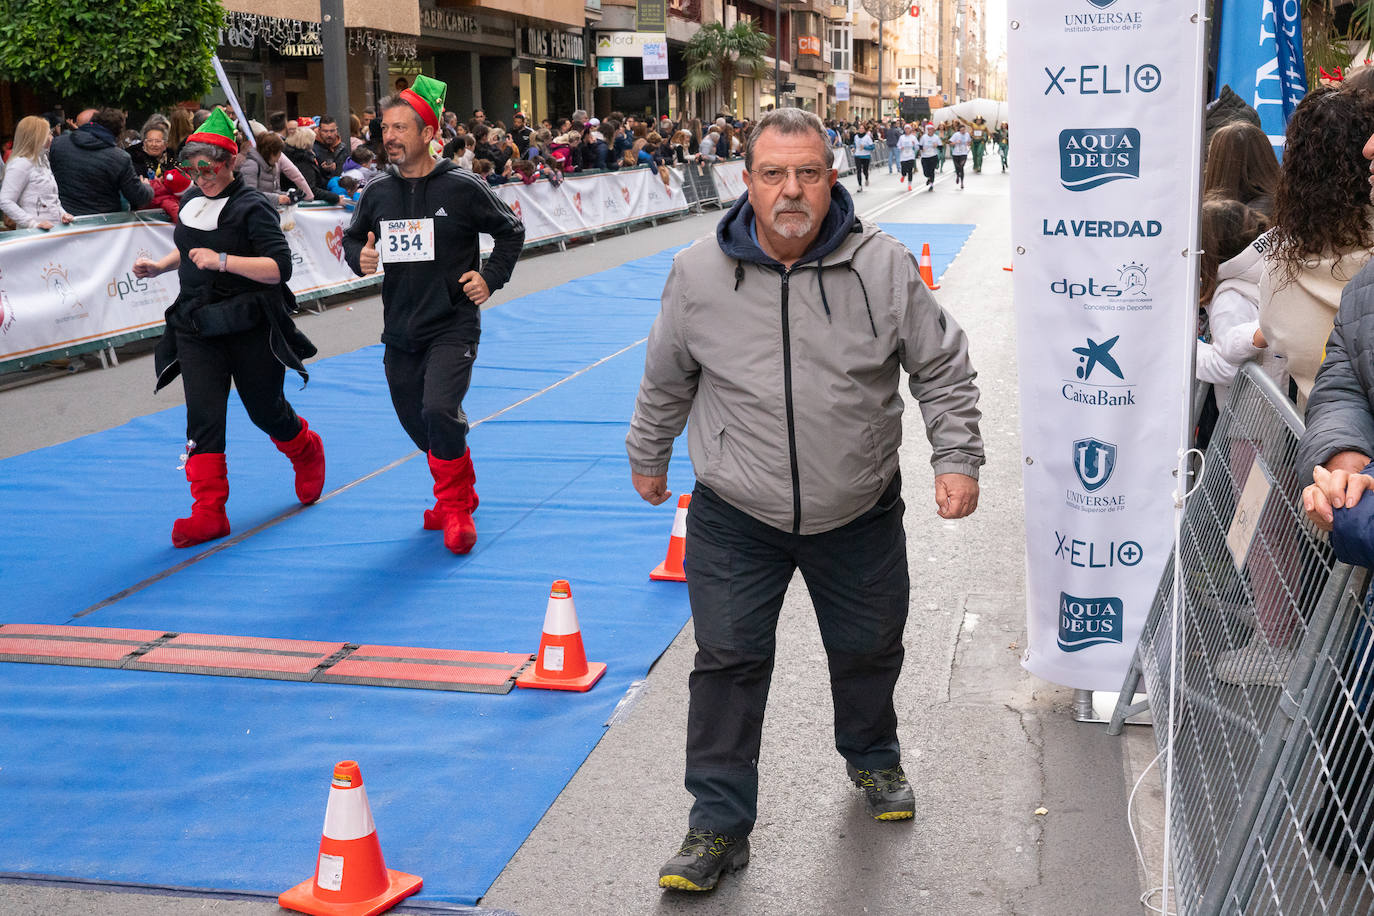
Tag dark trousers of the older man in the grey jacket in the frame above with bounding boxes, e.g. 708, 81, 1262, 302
684, 474, 910, 836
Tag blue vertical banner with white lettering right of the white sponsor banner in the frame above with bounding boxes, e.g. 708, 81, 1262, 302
1216, 0, 1307, 155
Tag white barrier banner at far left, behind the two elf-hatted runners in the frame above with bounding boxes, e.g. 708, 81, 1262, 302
0, 207, 359, 361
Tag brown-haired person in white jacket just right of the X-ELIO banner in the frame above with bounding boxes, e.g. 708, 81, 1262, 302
1197, 198, 1287, 408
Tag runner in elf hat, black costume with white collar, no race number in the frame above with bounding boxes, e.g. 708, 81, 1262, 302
133, 108, 324, 547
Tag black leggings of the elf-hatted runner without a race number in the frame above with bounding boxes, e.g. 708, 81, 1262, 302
176, 321, 301, 455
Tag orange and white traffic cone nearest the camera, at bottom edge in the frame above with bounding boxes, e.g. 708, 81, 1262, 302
276, 761, 425, 916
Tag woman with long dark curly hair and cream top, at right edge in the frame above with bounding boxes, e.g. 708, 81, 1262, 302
1260, 88, 1374, 405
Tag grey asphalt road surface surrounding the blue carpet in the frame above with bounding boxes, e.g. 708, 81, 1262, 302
0, 158, 1161, 916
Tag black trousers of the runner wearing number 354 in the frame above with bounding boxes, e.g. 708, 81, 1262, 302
382, 341, 477, 461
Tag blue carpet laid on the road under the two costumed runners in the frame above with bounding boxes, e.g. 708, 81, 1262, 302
0, 224, 973, 908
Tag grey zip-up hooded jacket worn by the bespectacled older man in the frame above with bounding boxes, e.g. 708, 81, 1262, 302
625, 184, 984, 534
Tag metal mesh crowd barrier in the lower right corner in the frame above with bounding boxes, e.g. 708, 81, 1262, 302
1109, 364, 1374, 916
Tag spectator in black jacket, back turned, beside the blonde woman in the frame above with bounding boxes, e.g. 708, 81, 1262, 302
48, 121, 153, 216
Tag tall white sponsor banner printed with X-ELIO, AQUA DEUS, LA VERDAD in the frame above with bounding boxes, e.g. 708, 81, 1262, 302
1007, 0, 1205, 691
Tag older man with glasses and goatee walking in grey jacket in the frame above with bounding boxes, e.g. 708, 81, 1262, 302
627, 108, 984, 890
